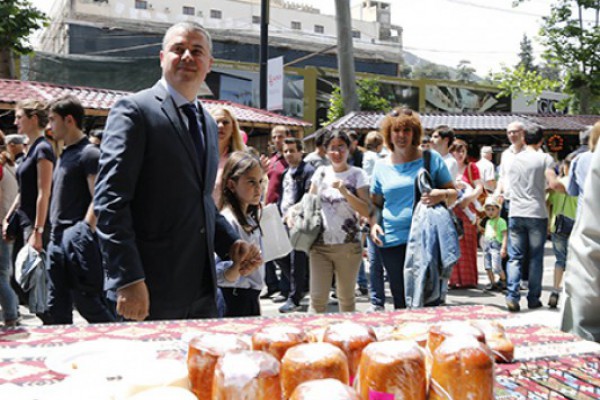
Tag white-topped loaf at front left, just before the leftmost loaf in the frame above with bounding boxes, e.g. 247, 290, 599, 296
213, 351, 281, 400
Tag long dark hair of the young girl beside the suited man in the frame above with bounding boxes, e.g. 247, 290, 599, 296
218, 151, 262, 234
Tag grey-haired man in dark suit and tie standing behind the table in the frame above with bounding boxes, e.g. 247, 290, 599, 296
94, 22, 262, 320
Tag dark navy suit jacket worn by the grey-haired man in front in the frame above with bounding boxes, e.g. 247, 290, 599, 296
94, 82, 238, 318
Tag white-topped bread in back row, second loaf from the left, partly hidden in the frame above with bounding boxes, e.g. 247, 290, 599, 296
252, 325, 308, 361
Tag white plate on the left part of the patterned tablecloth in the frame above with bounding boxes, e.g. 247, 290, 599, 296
45, 339, 156, 378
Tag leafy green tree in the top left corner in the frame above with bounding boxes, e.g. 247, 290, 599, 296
0, 0, 48, 78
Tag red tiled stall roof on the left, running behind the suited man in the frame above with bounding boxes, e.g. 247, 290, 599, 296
0, 79, 312, 128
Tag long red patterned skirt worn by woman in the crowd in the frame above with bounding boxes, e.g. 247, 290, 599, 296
449, 205, 477, 288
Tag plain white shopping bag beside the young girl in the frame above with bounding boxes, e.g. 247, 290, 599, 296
260, 204, 292, 262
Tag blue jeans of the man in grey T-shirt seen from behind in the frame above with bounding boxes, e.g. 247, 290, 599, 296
506, 217, 548, 307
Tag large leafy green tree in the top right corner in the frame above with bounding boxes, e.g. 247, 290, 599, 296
515, 0, 600, 114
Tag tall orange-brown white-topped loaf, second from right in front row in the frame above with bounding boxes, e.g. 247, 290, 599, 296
355, 340, 427, 400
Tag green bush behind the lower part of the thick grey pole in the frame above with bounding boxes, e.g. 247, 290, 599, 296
324, 79, 391, 125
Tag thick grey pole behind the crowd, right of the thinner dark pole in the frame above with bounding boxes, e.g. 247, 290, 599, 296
335, 0, 360, 114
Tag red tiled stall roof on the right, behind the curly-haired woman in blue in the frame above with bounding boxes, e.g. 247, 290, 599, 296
304, 111, 600, 140
